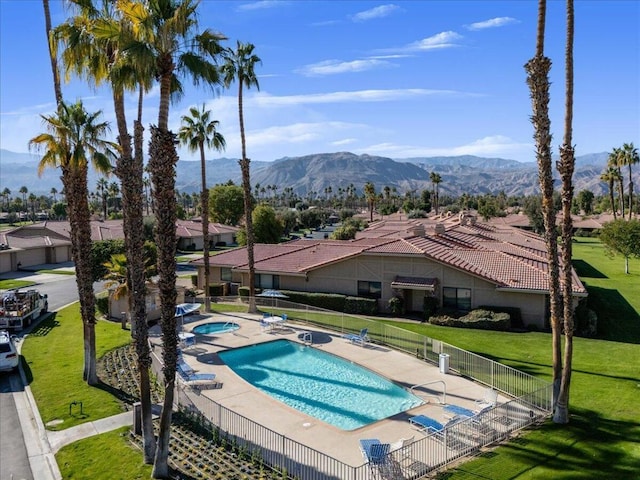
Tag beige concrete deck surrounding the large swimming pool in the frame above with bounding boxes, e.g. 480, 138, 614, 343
150, 313, 506, 466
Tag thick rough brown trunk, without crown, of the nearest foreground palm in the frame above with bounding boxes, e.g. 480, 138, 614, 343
149, 124, 178, 478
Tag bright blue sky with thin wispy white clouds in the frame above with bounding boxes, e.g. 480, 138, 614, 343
0, 0, 640, 165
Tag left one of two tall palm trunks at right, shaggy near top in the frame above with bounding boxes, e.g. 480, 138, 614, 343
525, 0, 562, 414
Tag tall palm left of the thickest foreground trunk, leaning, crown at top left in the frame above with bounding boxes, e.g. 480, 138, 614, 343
56, 0, 156, 464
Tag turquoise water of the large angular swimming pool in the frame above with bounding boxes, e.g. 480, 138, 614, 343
219, 340, 423, 430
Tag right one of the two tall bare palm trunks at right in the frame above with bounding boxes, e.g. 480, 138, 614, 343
553, 0, 575, 423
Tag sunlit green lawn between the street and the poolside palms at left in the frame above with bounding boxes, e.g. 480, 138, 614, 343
22, 303, 131, 430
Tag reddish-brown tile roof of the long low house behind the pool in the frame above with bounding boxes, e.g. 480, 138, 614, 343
200, 218, 586, 294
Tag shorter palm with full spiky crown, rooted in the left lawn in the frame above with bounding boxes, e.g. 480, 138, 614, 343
29, 102, 118, 385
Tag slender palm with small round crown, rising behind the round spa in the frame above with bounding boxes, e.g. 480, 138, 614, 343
222, 41, 262, 304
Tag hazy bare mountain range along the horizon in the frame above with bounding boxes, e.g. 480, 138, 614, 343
0, 150, 624, 197
